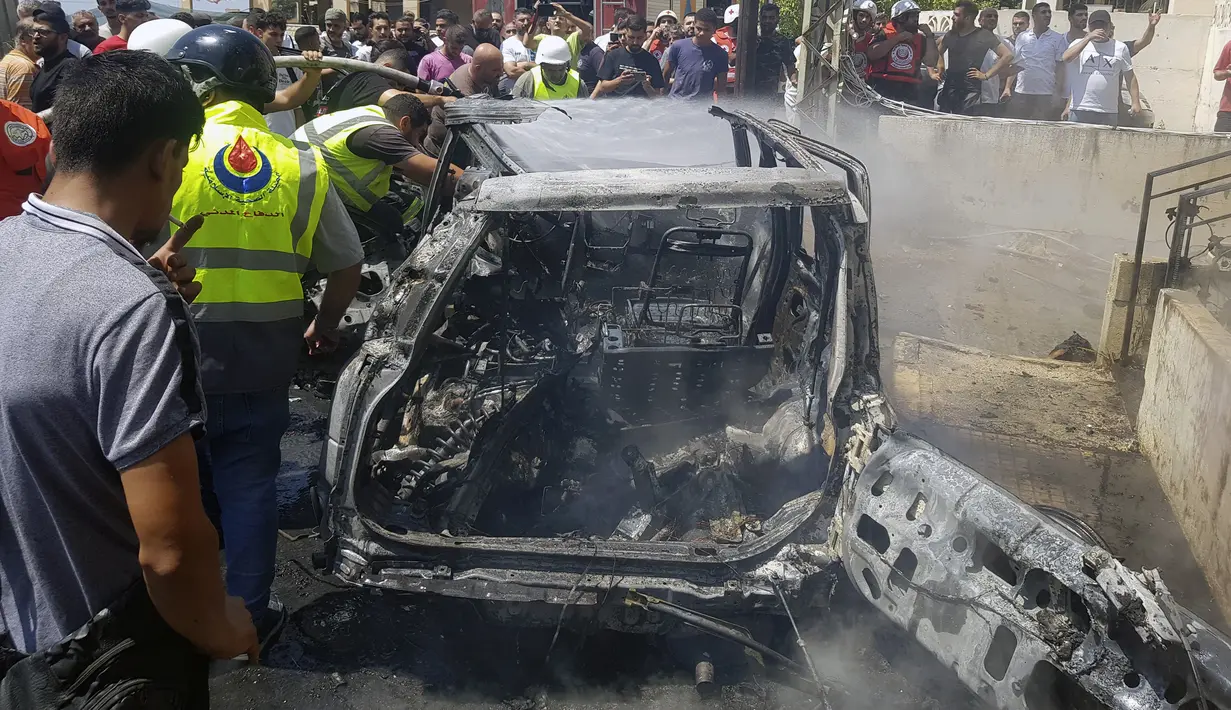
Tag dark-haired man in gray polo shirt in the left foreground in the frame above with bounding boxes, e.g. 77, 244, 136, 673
0, 52, 257, 708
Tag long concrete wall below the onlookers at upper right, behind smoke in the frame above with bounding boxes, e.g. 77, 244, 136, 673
878, 116, 1231, 256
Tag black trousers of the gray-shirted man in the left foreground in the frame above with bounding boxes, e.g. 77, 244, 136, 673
0, 582, 209, 710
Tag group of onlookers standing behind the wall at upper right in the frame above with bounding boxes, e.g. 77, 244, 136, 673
849, 0, 1161, 127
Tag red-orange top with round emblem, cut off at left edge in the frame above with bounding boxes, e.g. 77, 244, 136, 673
0, 100, 52, 219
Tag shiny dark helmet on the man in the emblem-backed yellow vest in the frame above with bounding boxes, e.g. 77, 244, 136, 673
166, 25, 278, 103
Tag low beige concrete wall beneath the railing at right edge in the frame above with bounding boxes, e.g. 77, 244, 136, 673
1137, 289, 1231, 616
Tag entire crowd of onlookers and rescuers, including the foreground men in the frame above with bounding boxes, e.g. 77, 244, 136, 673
0, 0, 1216, 710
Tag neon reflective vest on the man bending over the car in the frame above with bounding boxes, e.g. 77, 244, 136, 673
295, 106, 393, 212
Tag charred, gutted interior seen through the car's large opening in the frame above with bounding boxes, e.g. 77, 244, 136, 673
358, 209, 825, 544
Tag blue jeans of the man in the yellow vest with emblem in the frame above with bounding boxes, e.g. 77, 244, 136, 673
197, 386, 291, 621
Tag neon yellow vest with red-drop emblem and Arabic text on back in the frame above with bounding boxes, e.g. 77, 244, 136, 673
171, 101, 329, 322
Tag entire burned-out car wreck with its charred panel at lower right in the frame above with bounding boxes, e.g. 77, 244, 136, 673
315, 100, 1231, 709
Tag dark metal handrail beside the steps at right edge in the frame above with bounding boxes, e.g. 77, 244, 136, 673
1119, 150, 1231, 363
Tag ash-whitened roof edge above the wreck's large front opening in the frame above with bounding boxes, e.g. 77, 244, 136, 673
474, 167, 851, 212
